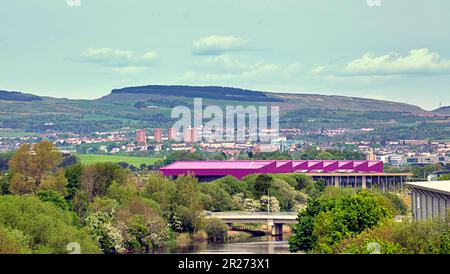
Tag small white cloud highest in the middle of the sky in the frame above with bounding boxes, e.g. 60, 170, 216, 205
192, 35, 248, 55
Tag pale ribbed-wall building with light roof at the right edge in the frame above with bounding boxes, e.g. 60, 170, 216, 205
406, 181, 450, 220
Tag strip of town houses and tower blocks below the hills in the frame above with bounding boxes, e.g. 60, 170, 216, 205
0, 125, 450, 167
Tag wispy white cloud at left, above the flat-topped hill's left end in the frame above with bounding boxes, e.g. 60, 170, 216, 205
77, 48, 158, 74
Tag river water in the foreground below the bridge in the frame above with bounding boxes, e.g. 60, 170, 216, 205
171, 235, 289, 254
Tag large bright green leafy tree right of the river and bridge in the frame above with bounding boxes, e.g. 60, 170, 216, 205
289, 188, 404, 253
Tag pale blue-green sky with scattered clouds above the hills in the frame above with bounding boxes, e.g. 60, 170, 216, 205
0, 0, 450, 110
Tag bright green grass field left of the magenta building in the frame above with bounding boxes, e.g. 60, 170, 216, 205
77, 154, 160, 167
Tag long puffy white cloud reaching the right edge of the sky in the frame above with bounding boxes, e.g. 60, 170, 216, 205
311, 48, 450, 76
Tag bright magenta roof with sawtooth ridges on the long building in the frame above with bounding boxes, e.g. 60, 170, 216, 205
160, 160, 383, 179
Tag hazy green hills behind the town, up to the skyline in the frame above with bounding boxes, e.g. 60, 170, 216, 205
0, 86, 450, 139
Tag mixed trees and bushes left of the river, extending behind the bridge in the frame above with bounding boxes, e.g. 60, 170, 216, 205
0, 141, 323, 253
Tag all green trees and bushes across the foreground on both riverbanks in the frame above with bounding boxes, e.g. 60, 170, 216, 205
5, 142, 450, 254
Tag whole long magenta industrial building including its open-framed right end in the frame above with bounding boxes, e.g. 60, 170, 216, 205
160, 160, 412, 191
